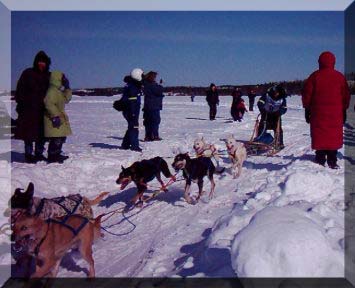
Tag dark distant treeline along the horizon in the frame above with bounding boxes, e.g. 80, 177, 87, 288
11, 78, 355, 96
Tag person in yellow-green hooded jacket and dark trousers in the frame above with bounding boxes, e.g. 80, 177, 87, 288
44, 71, 72, 163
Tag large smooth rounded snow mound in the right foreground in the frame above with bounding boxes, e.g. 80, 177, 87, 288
231, 206, 344, 277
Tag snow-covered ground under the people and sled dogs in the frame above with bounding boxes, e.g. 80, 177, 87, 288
0, 96, 355, 277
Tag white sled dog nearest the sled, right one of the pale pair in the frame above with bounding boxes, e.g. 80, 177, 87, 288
225, 135, 247, 178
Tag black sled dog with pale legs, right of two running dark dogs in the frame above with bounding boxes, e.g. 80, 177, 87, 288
172, 153, 216, 204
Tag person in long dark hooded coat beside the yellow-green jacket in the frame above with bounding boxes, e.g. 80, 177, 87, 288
15, 51, 51, 163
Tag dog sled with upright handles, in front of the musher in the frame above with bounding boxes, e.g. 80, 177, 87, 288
243, 114, 283, 156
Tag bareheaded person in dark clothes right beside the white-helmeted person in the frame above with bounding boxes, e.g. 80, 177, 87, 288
143, 71, 164, 141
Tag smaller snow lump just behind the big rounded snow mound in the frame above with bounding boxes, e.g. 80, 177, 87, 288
277, 171, 336, 206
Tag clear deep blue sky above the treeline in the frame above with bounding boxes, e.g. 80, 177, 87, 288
11, 11, 344, 88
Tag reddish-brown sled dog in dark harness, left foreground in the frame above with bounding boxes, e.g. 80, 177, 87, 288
13, 214, 103, 278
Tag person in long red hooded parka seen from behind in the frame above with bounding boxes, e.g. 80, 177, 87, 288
302, 51, 350, 169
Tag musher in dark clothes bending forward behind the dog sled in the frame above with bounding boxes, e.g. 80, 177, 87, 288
256, 84, 287, 149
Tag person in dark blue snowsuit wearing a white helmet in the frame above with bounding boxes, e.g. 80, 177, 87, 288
121, 68, 143, 152
